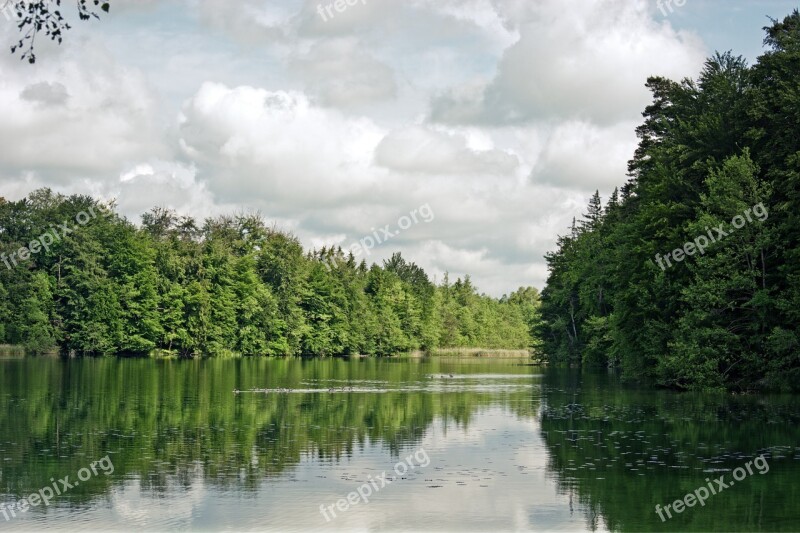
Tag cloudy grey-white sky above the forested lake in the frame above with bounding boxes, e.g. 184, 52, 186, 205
0, 0, 798, 296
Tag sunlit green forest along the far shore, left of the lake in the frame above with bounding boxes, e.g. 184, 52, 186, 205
0, 189, 539, 357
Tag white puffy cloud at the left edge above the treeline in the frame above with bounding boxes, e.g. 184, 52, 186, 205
0, 46, 164, 182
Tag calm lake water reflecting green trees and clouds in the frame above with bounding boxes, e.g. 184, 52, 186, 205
0, 359, 800, 531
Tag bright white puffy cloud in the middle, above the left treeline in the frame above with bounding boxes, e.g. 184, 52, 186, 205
180, 83, 384, 212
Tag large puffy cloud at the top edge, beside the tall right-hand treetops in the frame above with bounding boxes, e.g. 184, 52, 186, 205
431, 0, 705, 124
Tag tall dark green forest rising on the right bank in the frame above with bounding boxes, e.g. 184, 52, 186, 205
538, 10, 800, 390
